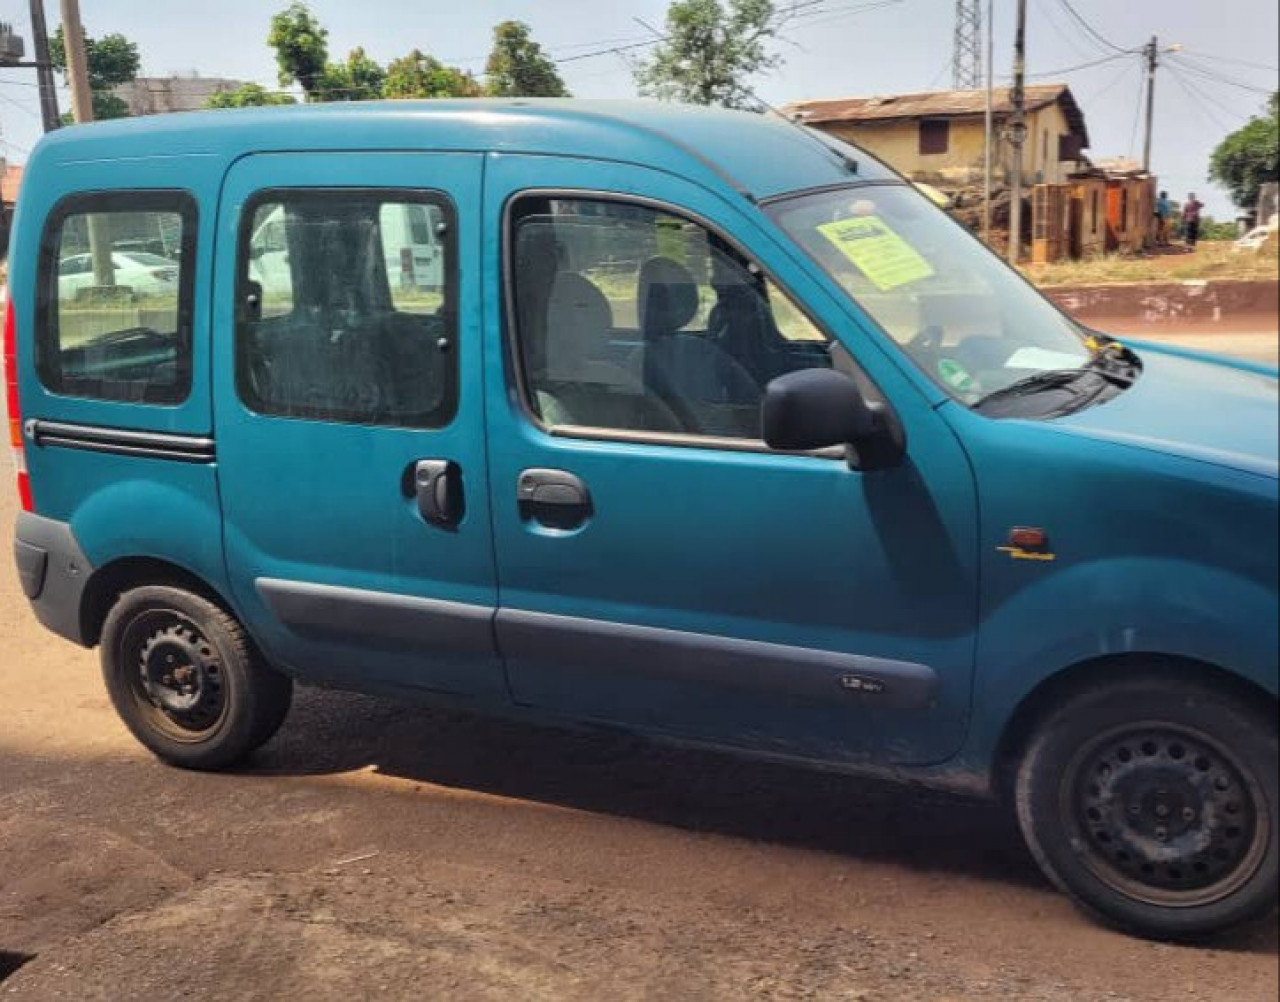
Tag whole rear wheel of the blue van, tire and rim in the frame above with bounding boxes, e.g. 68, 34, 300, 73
101, 585, 293, 770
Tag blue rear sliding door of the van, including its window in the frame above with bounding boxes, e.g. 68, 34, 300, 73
214, 151, 506, 701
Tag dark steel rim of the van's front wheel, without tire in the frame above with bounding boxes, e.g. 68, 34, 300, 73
1059, 722, 1271, 909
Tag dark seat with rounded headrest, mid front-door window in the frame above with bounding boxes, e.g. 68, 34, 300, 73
637, 257, 760, 438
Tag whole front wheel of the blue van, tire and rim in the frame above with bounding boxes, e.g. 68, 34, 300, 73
1015, 672, 1280, 939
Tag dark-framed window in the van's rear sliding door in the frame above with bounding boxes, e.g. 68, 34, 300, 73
236, 188, 457, 427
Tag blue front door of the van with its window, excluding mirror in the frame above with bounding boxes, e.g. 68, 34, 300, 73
485, 156, 977, 763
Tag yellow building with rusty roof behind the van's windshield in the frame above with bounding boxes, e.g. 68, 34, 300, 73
783, 83, 1089, 191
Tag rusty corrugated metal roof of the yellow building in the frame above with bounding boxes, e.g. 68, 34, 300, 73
782, 83, 1089, 147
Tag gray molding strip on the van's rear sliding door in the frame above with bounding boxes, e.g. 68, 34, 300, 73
253, 577, 498, 658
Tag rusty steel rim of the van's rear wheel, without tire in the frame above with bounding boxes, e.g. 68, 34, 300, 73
118, 609, 228, 744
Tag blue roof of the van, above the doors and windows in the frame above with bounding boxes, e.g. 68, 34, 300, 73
32, 99, 896, 200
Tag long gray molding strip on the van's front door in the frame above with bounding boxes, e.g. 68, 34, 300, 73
495, 609, 938, 710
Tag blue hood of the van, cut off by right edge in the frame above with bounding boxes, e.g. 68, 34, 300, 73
1053, 340, 1280, 477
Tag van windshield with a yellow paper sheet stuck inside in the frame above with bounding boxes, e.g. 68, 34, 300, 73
769, 184, 1094, 404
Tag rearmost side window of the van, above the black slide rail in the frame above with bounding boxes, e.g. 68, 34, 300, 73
36, 191, 196, 404
